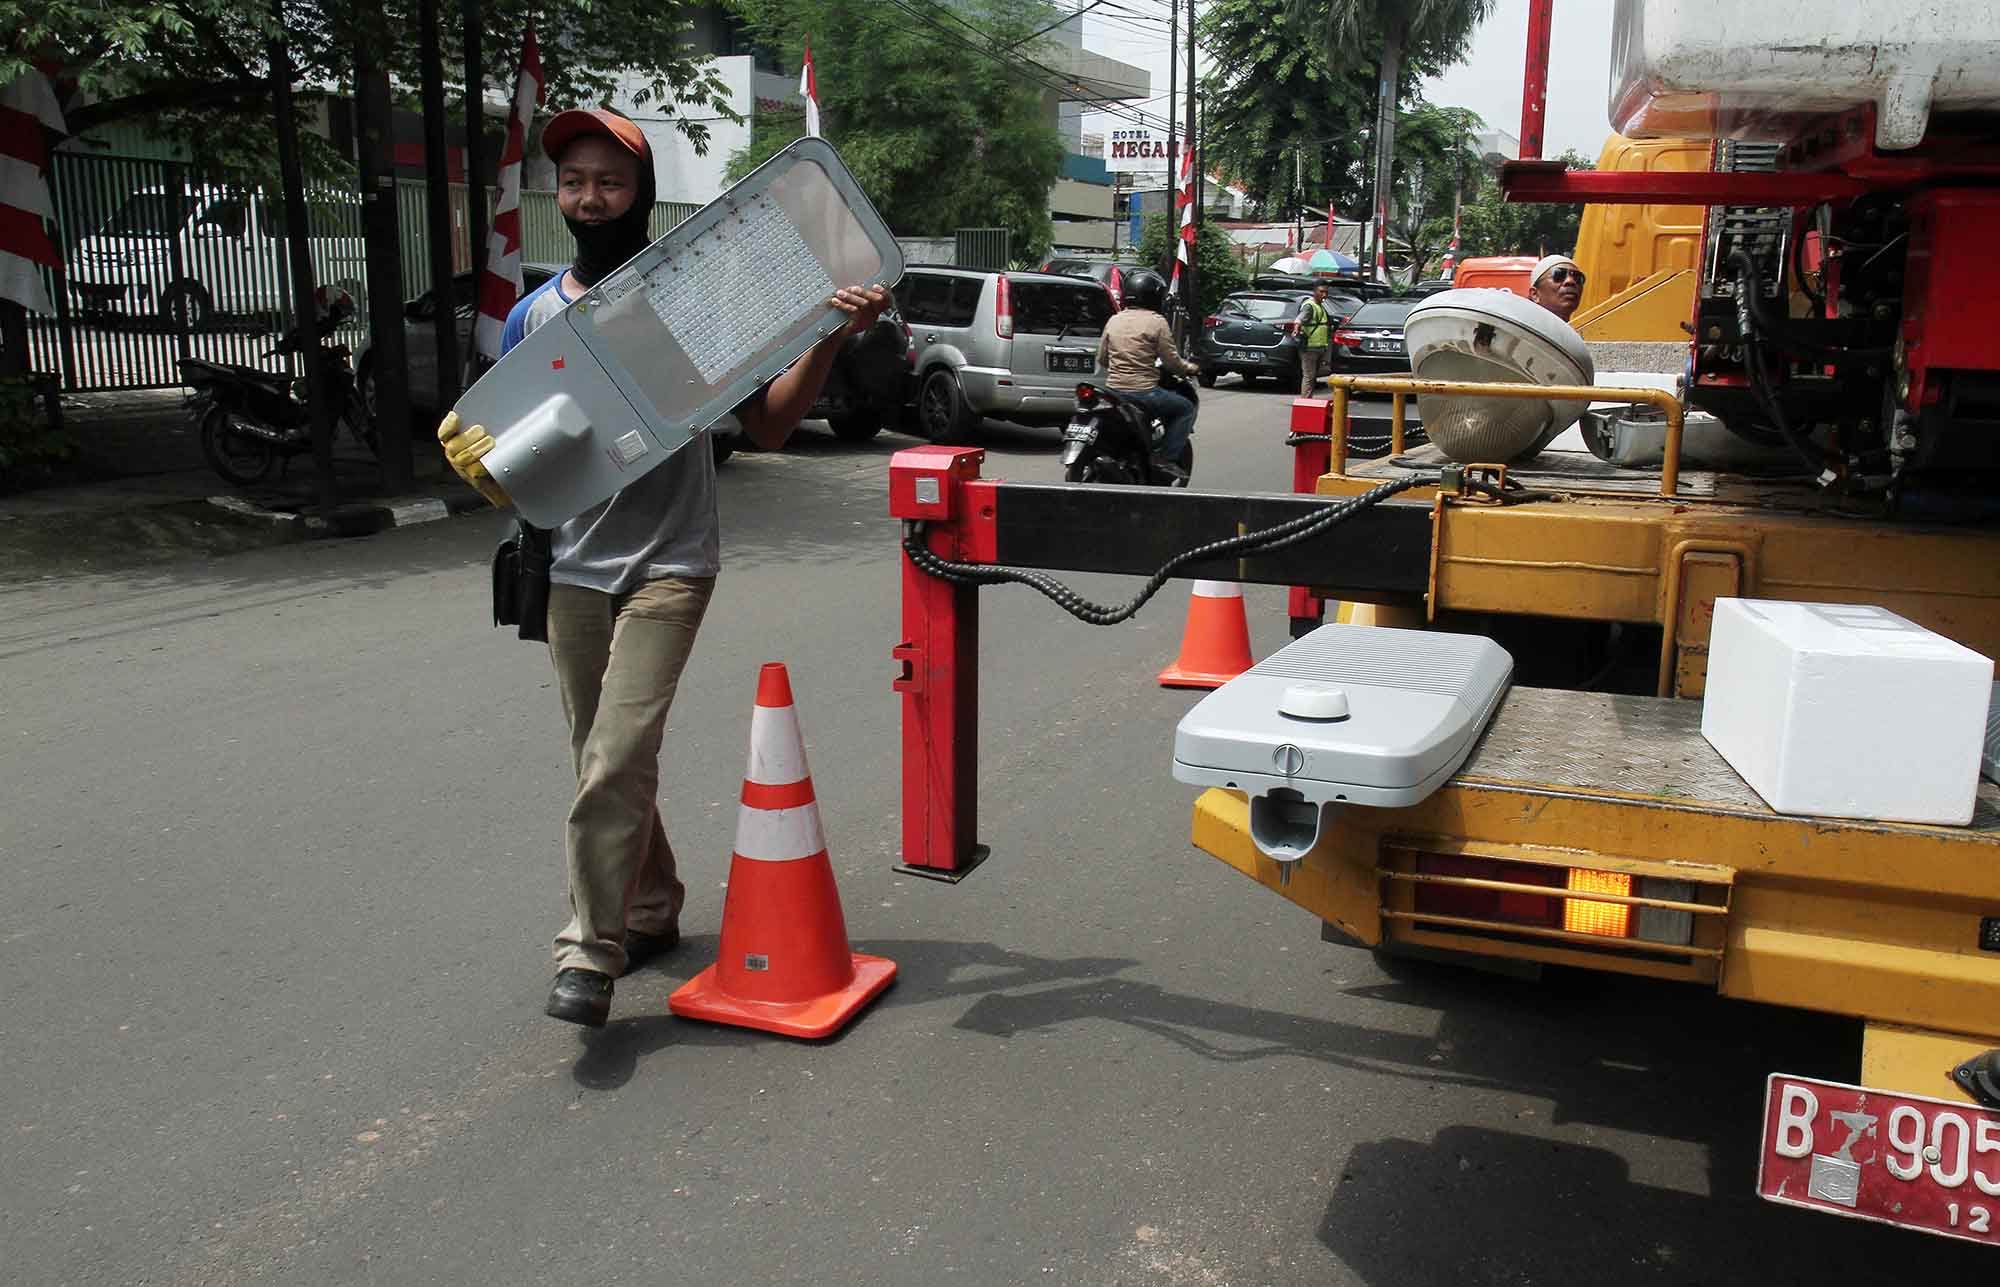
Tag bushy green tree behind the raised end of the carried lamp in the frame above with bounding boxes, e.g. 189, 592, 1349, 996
728, 0, 1064, 262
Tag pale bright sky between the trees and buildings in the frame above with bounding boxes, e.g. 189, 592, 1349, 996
1084, 0, 1612, 178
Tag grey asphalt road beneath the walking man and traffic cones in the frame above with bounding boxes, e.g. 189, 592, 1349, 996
0, 390, 1990, 1287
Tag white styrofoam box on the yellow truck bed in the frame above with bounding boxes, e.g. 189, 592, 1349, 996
1702, 600, 1994, 825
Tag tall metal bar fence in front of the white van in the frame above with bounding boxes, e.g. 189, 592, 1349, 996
17, 152, 698, 392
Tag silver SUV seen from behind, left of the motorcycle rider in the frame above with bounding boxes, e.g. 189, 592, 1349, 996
896, 266, 1116, 442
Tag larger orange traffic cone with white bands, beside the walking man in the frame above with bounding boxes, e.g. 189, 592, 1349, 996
666, 661, 896, 1037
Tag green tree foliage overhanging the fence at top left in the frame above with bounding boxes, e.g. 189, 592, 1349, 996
0, 0, 736, 174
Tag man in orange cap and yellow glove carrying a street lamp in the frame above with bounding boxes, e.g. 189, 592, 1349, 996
438, 110, 890, 1027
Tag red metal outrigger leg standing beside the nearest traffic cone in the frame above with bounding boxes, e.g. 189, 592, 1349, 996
888, 448, 988, 881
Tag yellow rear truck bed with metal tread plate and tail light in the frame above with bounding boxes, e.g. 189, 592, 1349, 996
1194, 687, 2000, 1097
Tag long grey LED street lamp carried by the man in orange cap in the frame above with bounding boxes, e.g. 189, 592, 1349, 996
454, 138, 902, 528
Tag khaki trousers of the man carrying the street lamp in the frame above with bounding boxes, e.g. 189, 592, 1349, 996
548, 578, 716, 977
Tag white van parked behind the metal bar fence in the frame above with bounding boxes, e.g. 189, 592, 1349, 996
68, 188, 368, 330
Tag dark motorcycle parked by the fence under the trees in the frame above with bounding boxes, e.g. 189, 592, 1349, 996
180, 288, 380, 486
